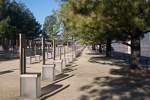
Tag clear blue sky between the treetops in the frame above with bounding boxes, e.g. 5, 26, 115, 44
12, 0, 59, 25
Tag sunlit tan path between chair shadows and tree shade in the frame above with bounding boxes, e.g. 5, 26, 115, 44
38, 49, 127, 100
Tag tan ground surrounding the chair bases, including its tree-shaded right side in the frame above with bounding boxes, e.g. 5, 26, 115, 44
0, 49, 150, 100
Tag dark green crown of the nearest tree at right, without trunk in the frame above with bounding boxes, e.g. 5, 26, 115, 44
102, 0, 150, 36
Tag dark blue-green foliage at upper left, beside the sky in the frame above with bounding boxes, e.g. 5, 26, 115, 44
0, 0, 42, 39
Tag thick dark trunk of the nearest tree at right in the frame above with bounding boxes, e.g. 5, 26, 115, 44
130, 36, 142, 69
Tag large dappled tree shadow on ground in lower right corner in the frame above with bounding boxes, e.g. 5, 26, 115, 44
79, 68, 150, 100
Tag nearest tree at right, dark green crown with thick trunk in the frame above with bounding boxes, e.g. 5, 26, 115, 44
99, 0, 150, 69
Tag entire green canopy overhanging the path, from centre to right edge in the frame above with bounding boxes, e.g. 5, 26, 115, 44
57, 0, 150, 43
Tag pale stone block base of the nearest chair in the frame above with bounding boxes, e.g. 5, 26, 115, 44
20, 73, 41, 98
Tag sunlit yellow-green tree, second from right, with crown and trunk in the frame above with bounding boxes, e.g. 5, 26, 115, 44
58, 0, 115, 56
